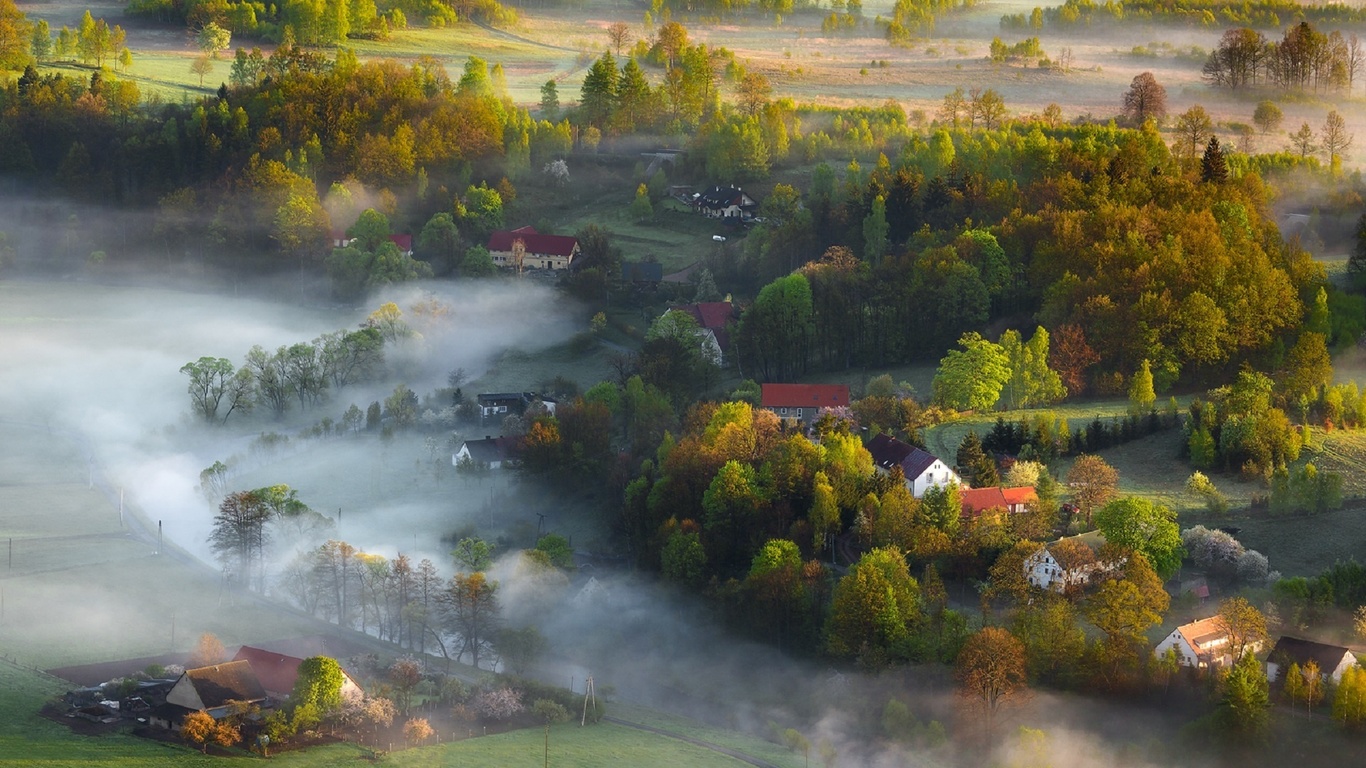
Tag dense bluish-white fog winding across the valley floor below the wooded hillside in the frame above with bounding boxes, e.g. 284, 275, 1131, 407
0, 274, 1223, 768
